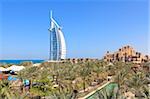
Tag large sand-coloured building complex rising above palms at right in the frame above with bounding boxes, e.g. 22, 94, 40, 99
104, 46, 149, 64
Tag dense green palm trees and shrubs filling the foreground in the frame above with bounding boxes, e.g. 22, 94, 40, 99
0, 60, 150, 99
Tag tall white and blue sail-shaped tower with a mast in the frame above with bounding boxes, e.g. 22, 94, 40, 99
48, 11, 66, 61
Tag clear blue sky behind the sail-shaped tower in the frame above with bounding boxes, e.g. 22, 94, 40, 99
0, 0, 149, 59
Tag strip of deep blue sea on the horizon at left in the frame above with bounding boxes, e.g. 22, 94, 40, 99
0, 60, 45, 64
